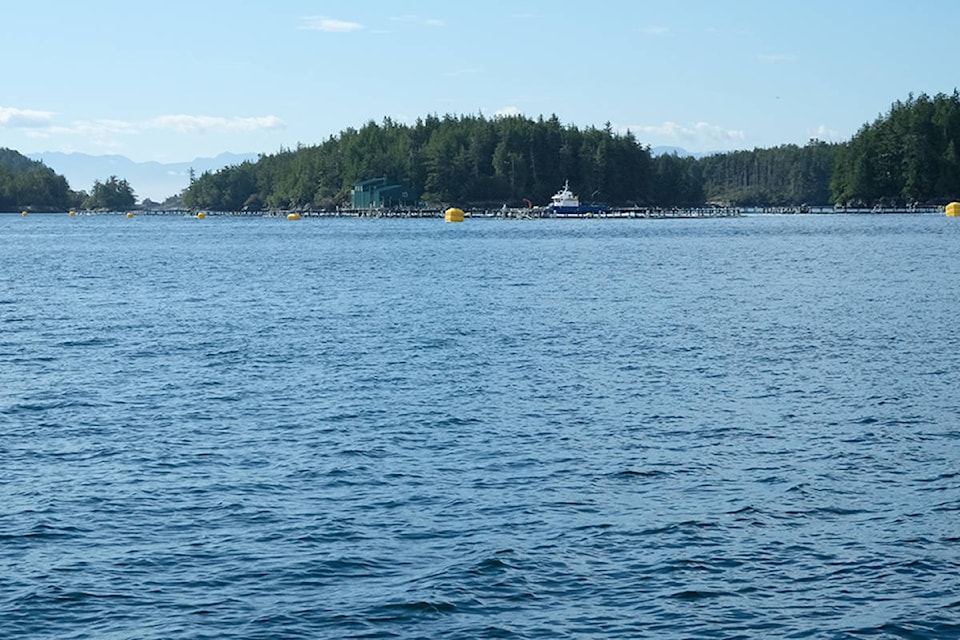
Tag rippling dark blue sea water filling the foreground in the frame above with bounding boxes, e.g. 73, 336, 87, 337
0, 214, 960, 640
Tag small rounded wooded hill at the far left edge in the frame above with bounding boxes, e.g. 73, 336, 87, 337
0, 149, 78, 211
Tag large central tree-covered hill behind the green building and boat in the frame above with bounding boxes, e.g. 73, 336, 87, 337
183, 115, 704, 210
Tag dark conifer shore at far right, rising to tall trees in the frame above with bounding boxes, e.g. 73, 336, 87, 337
699, 89, 960, 206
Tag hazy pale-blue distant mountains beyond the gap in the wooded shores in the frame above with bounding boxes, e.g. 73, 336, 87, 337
27, 151, 259, 202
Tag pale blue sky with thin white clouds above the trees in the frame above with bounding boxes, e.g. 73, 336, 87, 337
0, 0, 960, 162
